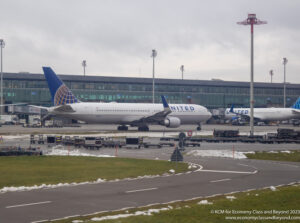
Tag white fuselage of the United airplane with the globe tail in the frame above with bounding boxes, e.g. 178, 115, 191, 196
49, 102, 211, 124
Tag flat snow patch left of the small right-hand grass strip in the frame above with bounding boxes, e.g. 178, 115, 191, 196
187, 150, 247, 159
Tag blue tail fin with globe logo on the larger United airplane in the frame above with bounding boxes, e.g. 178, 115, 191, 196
43, 67, 80, 106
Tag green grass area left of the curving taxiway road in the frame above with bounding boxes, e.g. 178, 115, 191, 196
0, 156, 188, 188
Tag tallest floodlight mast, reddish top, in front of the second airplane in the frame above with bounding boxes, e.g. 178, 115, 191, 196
237, 14, 267, 136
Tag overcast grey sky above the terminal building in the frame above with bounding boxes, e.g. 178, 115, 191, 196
0, 0, 300, 83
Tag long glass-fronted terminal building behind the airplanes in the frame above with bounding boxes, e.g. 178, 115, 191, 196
3, 73, 300, 109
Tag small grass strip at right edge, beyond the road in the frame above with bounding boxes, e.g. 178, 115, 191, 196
245, 150, 300, 162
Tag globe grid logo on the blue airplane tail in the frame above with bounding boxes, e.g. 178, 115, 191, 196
54, 84, 79, 106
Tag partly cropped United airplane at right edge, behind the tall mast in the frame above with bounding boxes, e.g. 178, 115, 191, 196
225, 97, 300, 122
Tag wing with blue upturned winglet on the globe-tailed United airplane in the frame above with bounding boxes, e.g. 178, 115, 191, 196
130, 95, 172, 125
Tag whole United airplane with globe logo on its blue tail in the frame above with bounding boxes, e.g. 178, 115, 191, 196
35, 67, 211, 131
